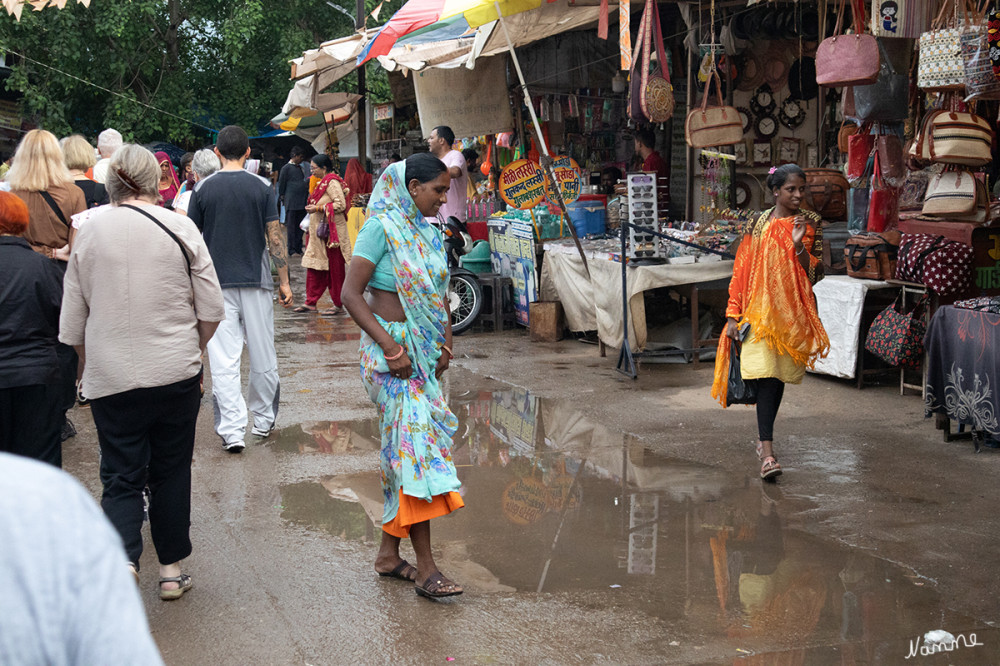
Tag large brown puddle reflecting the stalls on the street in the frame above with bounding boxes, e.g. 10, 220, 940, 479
269, 390, 1000, 664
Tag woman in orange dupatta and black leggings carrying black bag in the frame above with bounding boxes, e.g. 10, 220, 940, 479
712, 164, 830, 479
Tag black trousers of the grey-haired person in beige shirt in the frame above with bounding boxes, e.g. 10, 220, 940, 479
90, 373, 201, 566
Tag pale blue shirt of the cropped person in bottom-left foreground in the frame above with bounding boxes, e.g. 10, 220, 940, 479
0, 453, 163, 666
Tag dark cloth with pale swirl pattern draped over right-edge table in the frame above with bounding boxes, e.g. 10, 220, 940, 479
924, 305, 1000, 448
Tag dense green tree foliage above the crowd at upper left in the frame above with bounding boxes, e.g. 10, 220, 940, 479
0, 0, 401, 146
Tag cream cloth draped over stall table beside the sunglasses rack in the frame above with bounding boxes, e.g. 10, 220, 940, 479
540, 241, 733, 351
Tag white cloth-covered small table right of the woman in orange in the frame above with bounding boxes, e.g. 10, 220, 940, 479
812, 275, 897, 387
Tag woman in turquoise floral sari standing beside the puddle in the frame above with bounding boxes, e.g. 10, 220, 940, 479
343, 153, 464, 598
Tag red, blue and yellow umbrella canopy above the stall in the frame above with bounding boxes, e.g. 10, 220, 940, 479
358, 0, 554, 65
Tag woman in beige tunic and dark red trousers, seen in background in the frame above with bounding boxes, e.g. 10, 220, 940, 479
294, 154, 351, 315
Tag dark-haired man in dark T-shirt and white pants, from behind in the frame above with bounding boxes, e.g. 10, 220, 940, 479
187, 125, 292, 453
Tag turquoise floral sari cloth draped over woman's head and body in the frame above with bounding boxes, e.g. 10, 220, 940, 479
360, 162, 461, 524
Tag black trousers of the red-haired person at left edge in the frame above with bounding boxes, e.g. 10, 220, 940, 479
0, 384, 65, 467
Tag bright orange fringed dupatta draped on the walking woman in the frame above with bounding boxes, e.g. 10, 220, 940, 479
712, 209, 830, 406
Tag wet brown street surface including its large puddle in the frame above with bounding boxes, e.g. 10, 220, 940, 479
58, 261, 1000, 665
